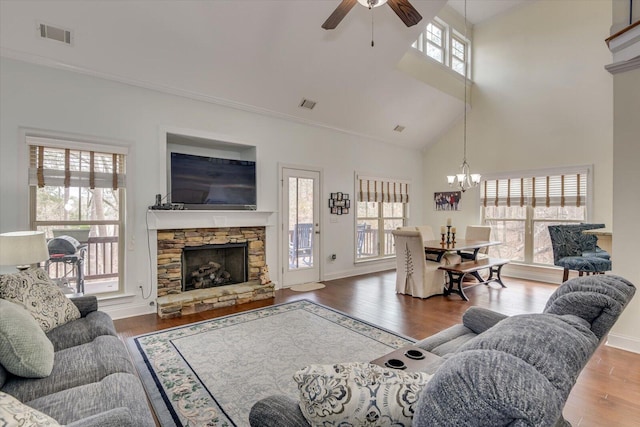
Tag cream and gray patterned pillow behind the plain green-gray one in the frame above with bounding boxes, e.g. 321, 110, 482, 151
0, 268, 80, 332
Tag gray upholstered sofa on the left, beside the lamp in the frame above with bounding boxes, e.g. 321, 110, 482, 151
0, 272, 155, 427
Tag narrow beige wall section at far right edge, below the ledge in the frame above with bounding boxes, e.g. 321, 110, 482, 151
609, 66, 640, 353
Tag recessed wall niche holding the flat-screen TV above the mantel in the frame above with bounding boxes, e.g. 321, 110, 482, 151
167, 133, 257, 210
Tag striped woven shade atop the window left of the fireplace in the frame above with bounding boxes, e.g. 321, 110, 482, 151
27, 137, 125, 190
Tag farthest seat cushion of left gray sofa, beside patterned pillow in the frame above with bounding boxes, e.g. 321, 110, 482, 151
47, 311, 116, 351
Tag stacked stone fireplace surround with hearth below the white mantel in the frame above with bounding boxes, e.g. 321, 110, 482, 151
157, 226, 274, 318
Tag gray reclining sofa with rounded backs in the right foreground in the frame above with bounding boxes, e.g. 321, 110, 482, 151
250, 275, 635, 427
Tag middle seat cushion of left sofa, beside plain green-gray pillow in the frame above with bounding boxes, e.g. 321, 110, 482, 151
3, 335, 135, 402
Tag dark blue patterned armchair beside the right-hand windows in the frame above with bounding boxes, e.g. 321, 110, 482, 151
548, 224, 611, 282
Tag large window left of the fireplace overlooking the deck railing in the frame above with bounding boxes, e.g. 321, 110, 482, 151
25, 135, 127, 294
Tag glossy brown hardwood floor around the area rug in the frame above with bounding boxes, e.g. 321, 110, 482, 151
115, 271, 640, 427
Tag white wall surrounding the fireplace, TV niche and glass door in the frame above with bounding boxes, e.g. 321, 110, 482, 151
0, 58, 423, 317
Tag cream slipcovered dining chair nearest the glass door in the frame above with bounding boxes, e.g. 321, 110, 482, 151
393, 231, 460, 298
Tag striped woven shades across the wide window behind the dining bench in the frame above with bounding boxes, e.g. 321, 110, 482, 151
481, 169, 588, 207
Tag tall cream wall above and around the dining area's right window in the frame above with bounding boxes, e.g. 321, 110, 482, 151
423, 0, 613, 254
